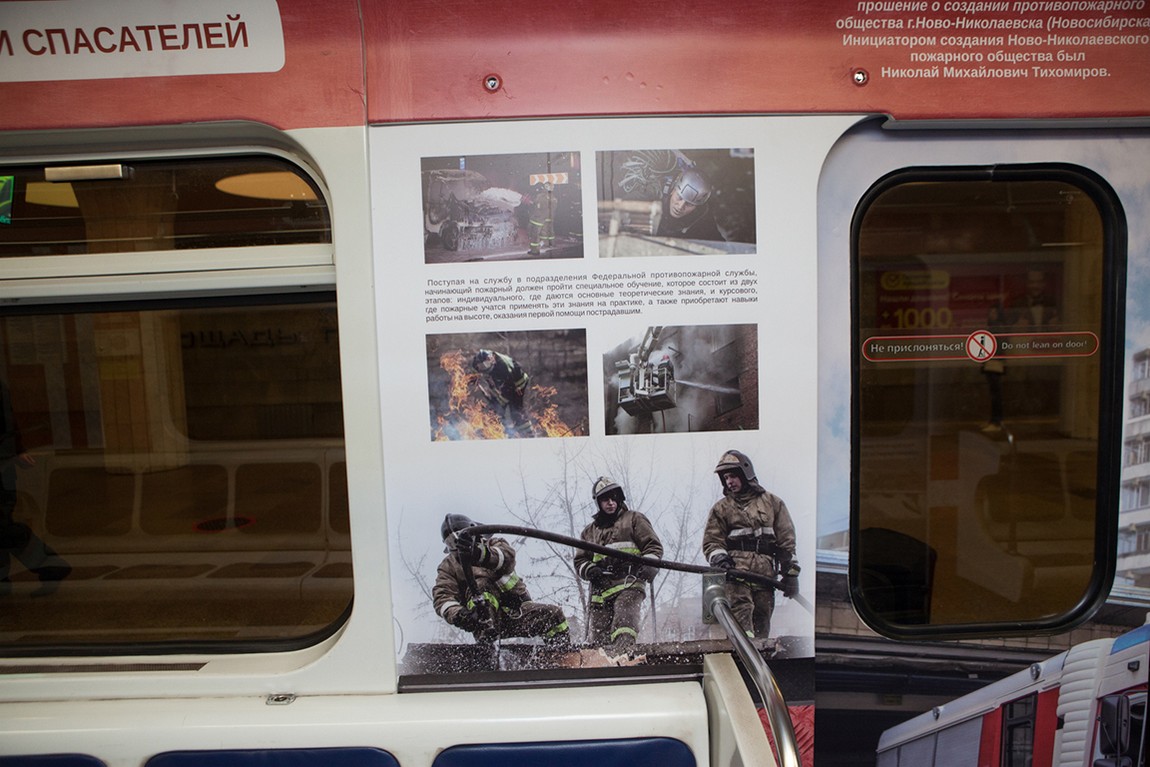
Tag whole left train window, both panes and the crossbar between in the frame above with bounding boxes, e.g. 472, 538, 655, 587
0, 149, 352, 655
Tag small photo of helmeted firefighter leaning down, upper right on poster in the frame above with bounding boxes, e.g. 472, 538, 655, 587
596, 148, 756, 259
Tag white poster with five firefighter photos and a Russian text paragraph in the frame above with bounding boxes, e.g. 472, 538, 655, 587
370, 118, 815, 675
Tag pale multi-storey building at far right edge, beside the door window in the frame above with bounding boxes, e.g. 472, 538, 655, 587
1117, 348, 1150, 586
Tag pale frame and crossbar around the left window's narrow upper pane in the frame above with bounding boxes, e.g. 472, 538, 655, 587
0, 121, 337, 306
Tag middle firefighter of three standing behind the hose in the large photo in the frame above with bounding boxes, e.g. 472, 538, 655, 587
575, 477, 662, 655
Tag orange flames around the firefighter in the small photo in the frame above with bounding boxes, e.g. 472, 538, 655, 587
434, 351, 582, 442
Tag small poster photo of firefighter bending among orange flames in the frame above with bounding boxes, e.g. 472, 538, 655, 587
427, 329, 588, 442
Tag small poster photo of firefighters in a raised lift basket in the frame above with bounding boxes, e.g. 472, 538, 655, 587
603, 324, 759, 435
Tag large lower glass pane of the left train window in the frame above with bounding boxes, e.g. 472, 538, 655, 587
0, 296, 352, 654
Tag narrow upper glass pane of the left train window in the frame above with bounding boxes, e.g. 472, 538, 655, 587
0, 155, 331, 259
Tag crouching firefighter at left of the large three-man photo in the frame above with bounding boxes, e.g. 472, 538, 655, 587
431, 514, 570, 647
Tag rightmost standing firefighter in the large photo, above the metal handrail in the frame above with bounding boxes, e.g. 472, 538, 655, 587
703, 450, 799, 637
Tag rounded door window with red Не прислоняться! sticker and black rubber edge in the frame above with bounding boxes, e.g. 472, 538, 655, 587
850, 166, 1124, 636
